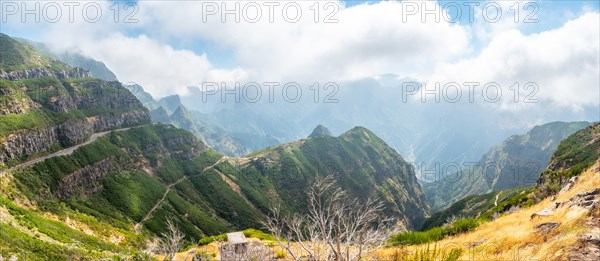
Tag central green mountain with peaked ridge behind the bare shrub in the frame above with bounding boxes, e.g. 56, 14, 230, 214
247, 127, 429, 228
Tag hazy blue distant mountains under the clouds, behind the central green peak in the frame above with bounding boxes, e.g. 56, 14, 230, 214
173, 77, 515, 176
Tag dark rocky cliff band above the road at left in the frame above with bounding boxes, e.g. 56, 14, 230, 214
0, 82, 150, 164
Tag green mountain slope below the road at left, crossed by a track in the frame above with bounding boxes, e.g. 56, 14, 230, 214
0, 125, 263, 257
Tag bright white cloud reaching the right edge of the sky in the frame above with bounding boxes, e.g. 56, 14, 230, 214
421, 13, 600, 112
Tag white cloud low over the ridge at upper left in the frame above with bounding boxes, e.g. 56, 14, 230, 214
79, 34, 246, 97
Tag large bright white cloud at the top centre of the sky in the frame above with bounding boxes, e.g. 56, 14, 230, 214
134, 1, 468, 81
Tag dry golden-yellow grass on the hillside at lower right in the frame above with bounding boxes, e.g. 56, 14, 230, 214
373, 162, 600, 260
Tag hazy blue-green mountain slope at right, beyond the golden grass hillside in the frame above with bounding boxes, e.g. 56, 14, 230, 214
423, 122, 589, 210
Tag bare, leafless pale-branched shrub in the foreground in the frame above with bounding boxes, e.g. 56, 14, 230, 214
265, 176, 400, 261
